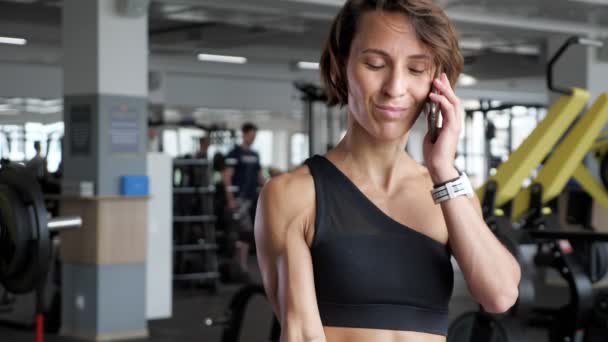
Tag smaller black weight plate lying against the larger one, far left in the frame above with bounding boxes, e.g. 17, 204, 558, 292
0, 184, 32, 281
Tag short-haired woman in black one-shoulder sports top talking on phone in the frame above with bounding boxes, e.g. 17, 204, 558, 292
255, 0, 520, 342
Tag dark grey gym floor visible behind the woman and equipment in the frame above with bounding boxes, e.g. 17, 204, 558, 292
0, 259, 552, 342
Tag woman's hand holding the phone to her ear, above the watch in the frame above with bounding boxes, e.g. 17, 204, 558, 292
423, 73, 463, 184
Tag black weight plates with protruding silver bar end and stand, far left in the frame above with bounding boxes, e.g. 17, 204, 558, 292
0, 164, 82, 341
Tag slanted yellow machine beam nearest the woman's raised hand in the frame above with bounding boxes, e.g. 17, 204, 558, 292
477, 88, 590, 207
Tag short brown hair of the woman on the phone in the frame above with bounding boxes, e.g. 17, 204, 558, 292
319, 0, 464, 106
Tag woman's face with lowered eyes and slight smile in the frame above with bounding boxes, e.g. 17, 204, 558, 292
346, 11, 433, 140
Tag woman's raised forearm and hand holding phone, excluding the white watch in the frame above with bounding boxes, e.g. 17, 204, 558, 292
424, 74, 521, 313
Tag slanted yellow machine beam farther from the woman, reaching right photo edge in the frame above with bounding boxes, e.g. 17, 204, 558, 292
511, 93, 608, 220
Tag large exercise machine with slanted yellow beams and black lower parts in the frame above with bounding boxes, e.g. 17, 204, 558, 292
448, 37, 608, 342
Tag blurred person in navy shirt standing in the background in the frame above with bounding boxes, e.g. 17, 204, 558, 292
223, 123, 265, 278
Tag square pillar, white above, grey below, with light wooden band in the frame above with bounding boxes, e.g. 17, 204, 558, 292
61, 0, 148, 341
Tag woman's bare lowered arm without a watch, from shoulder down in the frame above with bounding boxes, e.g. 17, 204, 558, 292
255, 174, 325, 342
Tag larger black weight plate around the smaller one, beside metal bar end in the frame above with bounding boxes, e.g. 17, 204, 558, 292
0, 165, 51, 294
